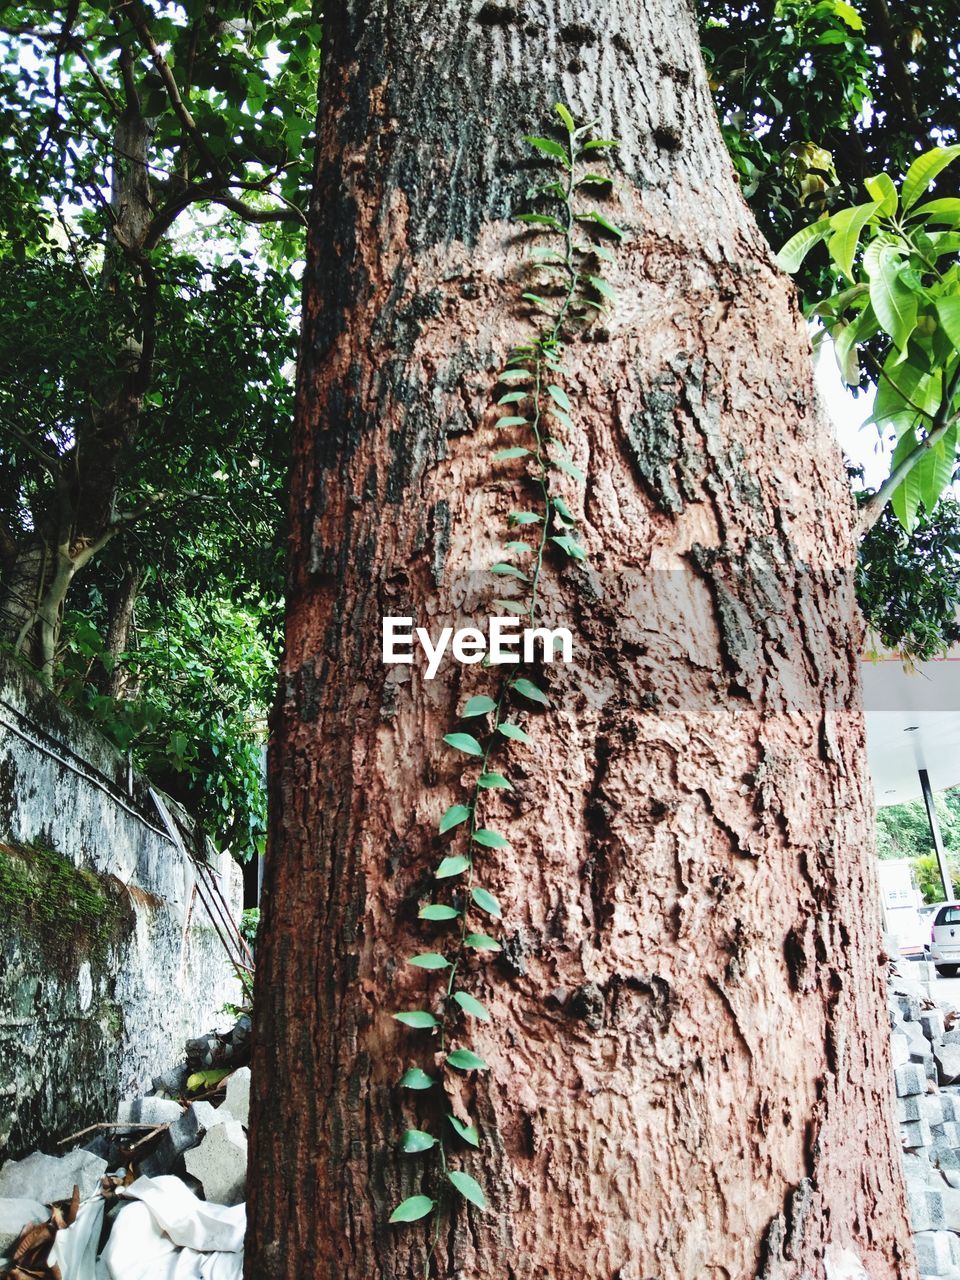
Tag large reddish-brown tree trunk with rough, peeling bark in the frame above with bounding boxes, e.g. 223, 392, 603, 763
247, 0, 914, 1280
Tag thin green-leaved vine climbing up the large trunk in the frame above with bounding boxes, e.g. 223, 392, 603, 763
390, 104, 623, 1277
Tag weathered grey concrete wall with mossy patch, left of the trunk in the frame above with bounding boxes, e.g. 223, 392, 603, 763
0, 658, 242, 1160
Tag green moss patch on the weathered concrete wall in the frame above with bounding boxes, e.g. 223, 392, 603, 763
0, 841, 129, 972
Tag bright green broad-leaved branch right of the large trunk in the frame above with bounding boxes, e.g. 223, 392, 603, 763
780, 146, 960, 531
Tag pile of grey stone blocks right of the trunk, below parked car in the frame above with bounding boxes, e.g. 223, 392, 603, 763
888, 963, 960, 1280
